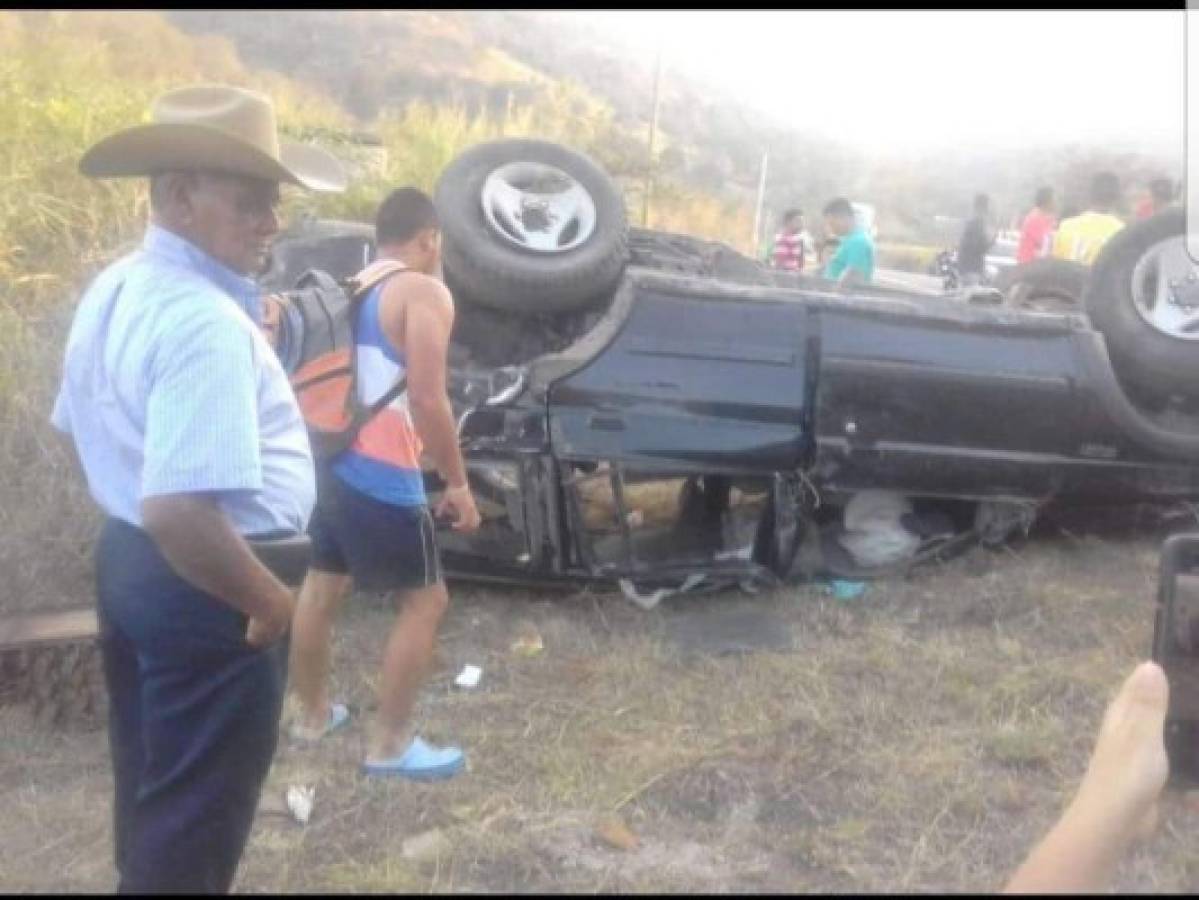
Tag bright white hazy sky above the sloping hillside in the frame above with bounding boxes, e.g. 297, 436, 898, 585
572, 11, 1179, 155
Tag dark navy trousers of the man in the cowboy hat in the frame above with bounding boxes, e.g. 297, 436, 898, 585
96, 519, 287, 893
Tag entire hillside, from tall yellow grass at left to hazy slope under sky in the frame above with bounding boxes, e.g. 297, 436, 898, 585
0, 10, 1174, 606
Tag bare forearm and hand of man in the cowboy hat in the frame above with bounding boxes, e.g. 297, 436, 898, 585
141, 494, 294, 645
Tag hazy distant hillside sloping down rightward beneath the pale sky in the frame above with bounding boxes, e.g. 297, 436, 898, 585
168, 10, 1181, 247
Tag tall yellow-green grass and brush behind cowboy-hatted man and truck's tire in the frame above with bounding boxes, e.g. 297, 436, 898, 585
0, 11, 751, 609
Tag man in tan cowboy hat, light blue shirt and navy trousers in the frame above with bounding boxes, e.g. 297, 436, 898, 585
53, 85, 345, 893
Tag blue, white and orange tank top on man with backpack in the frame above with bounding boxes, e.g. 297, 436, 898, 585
332, 263, 428, 506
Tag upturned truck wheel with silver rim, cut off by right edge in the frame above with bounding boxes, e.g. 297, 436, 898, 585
1084, 207, 1199, 398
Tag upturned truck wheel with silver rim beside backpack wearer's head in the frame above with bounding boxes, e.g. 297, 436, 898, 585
434, 140, 628, 314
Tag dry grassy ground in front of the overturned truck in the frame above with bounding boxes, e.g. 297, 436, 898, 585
7, 510, 1199, 893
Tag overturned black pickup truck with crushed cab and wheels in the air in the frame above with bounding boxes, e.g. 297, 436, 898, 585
261, 140, 1199, 606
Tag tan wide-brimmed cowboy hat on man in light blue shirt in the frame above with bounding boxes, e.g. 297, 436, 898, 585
79, 85, 347, 191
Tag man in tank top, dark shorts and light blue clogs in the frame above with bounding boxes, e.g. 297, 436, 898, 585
290, 188, 480, 780
